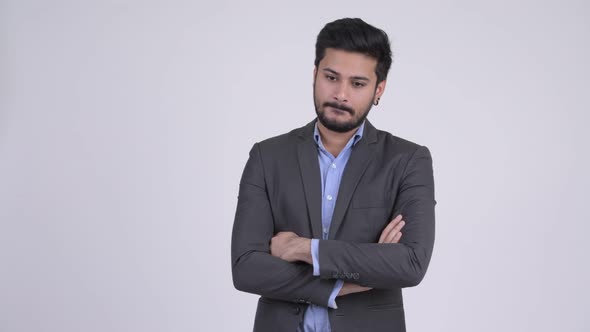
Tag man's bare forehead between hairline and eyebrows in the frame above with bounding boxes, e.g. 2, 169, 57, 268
318, 48, 377, 78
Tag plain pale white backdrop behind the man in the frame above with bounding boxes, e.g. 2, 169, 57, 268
0, 0, 590, 332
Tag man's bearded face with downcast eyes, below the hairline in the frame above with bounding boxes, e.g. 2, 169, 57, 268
313, 48, 385, 133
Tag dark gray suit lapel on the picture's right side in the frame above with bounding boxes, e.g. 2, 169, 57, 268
328, 120, 377, 239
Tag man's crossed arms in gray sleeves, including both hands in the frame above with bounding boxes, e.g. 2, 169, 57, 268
232, 144, 436, 306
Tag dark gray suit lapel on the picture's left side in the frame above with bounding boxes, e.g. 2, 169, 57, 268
297, 120, 322, 239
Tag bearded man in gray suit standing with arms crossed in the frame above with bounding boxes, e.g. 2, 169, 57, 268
232, 19, 436, 332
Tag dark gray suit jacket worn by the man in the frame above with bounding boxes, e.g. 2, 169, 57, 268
231, 120, 436, 332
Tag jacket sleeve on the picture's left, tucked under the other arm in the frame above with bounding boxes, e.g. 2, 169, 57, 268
231, 143, 336, 306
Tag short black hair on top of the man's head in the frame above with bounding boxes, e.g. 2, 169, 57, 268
314, 18, 392, 83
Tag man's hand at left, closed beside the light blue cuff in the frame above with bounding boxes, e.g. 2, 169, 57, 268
270, 232, 313, 264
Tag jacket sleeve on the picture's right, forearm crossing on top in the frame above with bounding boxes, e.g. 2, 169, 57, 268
319, 146, 436, 289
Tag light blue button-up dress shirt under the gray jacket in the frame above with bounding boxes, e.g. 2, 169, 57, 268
297, 122, 365, 332
